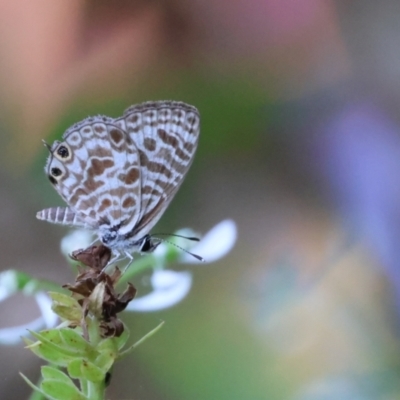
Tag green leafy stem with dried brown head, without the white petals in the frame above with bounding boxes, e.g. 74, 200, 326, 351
21, 245, 160, 400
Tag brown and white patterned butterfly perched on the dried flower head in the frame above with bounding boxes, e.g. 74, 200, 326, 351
36, 101, 200, 259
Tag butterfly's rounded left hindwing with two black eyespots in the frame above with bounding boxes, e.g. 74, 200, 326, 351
45, 117, 141, 229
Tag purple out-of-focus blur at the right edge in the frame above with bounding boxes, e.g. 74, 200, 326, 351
319, 104, 400, 305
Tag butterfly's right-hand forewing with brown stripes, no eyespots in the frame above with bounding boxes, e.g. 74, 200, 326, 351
116, 101, 200, 237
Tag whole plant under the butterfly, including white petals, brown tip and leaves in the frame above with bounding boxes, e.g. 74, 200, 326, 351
0, 220, 236, 400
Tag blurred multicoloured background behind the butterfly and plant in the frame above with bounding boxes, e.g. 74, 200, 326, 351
0, 0, 400, 400
